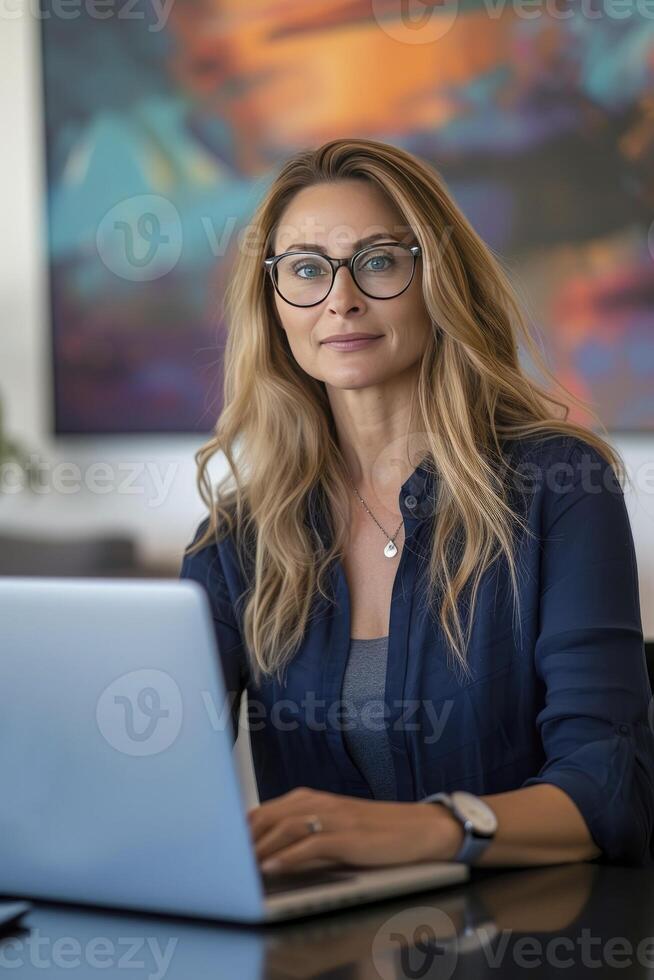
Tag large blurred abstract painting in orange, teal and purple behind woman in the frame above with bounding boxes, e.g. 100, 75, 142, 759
41, 0, 654, 433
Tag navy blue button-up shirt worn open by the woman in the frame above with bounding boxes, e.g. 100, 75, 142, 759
181, 436, 654, 865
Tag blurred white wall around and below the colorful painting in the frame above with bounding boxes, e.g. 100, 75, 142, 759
0, 11, 654, 637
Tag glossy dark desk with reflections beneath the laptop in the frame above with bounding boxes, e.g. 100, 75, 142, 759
0, 864, 654, 980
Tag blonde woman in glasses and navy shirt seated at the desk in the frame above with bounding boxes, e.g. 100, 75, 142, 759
181, 139, 654, 871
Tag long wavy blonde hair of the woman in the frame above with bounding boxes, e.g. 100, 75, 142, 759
185, 139, 625, 683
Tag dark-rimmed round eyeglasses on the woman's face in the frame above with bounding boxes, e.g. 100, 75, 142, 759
263, 242, 422, 306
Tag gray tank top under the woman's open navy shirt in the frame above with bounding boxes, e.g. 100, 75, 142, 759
341, 636, 397, 800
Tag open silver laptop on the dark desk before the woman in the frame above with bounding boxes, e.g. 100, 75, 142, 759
0, 577, 470, 923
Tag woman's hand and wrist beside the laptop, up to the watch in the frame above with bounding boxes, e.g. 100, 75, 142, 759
248, 786, 463, 871
